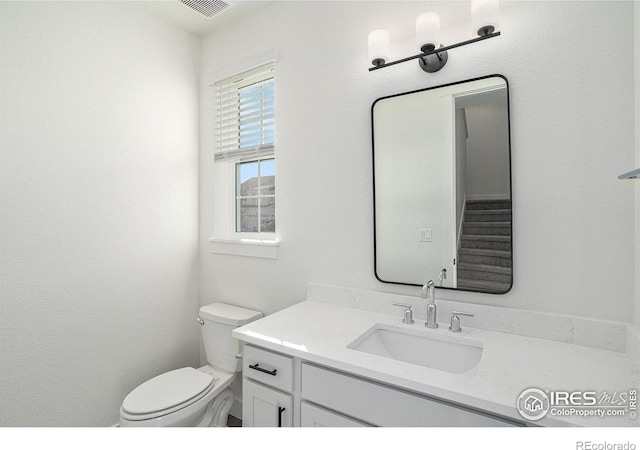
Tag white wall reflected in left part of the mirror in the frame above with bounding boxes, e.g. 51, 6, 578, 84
373, 91, 455, 283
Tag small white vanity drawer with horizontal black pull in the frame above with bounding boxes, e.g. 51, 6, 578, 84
242, 345, 293, 392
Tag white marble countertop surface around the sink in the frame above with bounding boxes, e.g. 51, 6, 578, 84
233, 300, 640, 427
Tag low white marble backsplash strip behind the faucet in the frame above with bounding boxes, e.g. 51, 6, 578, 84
307, 283, 639, 353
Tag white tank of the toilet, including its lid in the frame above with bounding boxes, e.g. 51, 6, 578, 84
200, 303, 262, 373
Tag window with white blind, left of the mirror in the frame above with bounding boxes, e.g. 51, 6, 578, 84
213, 59, 276, 250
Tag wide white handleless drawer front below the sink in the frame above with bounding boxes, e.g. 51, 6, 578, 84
302, 363, 520, 427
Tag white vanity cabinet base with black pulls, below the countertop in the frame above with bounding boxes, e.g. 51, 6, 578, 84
242, 345, 523, 427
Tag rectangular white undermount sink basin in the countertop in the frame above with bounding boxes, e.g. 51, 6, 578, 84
347, 324, 482, 373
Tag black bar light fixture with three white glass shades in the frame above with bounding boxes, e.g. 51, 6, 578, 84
369, 0, 500, 73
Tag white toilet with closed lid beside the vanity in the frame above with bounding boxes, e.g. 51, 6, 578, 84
120, 303, 262, 427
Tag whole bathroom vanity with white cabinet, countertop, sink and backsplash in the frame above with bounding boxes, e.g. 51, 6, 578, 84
233, 288, 640, 427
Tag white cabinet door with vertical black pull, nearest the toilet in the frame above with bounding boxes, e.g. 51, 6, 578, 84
242, 379, 293, 427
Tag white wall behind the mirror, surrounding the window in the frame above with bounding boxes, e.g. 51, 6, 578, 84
200, 2, 635, 321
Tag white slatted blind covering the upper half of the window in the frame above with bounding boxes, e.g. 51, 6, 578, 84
214, 63, 276, 161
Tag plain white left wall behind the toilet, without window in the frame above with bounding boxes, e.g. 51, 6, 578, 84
0, 2, 199, 426
